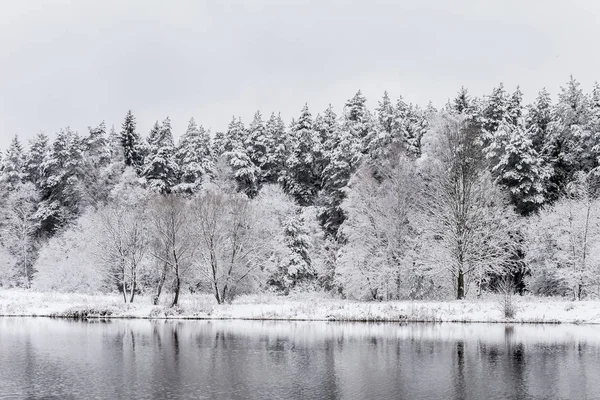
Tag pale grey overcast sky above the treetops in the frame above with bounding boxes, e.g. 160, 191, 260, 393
0, 0, 600, 148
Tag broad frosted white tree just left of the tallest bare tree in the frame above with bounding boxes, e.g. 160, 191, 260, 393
337, 157, 430, 300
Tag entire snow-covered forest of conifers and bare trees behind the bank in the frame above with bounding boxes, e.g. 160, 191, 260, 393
0, 78, 600, 304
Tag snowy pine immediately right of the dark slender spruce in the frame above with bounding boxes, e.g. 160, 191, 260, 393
142, 117, 179, 194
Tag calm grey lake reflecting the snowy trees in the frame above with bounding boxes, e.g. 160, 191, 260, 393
0, 318, 600, 399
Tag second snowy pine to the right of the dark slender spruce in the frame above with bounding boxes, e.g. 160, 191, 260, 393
176, 118, 213, 193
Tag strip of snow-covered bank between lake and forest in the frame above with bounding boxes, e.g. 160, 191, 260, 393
0, 290, 600, 324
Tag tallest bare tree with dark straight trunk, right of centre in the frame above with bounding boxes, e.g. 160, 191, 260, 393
421, 115, 515, 299
